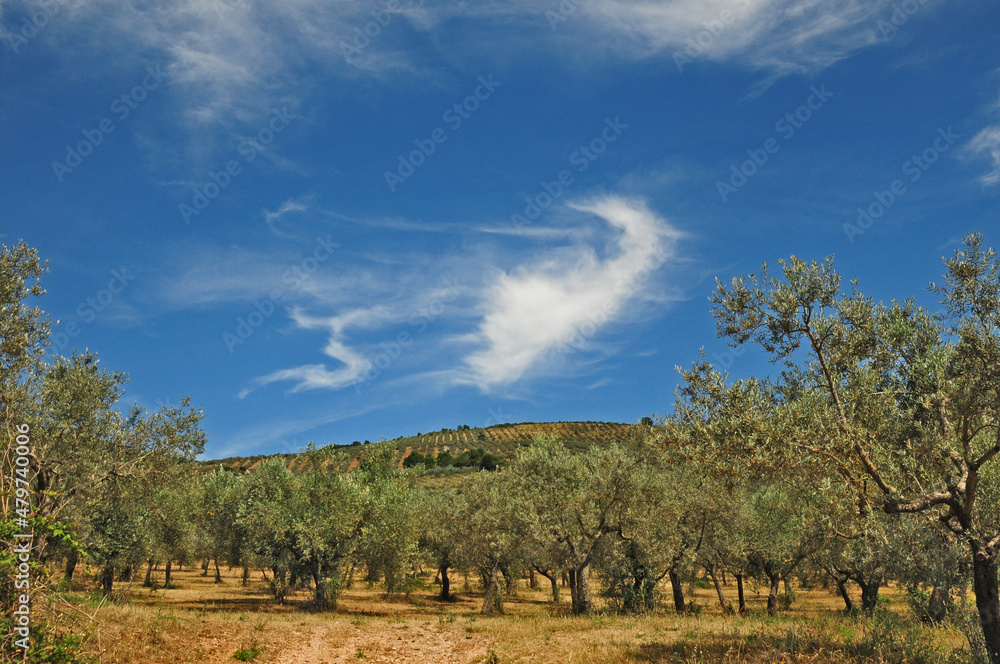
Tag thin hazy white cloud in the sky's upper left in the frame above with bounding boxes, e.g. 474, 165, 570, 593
29, 0, 416, 131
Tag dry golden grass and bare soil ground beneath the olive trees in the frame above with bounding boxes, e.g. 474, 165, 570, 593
43, 569, 961, 664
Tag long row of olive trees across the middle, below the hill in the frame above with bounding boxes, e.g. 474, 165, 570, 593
172, 426, 961, 617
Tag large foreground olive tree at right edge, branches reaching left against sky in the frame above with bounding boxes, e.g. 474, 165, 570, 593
712, 235, 1000, 664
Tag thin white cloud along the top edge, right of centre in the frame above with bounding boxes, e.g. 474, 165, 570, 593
451, 0, 904, 71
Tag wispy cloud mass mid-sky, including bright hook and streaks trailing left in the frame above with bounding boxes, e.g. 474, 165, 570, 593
178, 196, 682, 399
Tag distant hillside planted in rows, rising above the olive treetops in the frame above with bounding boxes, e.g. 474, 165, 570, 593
204, 422, 631, 473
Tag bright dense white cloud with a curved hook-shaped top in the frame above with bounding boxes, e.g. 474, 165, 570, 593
459, 196, 680, 389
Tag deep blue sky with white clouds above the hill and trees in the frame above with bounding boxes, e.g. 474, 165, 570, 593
0, 0, 1000, 457
